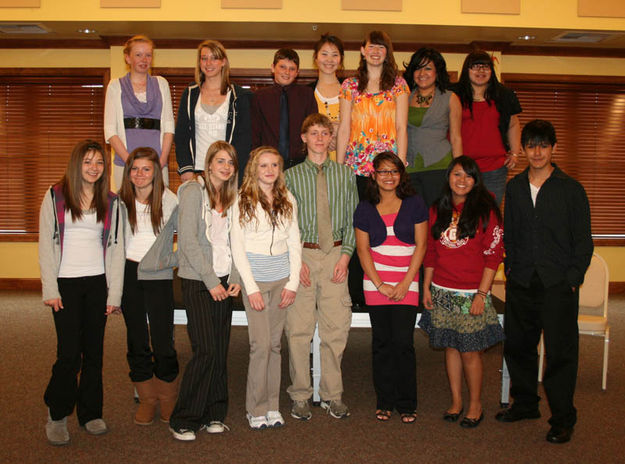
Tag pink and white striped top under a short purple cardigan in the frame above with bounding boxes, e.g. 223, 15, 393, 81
363, 213, 419, 306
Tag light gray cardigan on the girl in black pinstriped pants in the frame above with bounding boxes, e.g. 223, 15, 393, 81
178, 177, 240, 290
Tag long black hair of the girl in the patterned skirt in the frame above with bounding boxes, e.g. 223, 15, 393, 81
432, 155, 501, 240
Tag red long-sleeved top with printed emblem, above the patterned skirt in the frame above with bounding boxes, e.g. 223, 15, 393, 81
423, 203, 503, 290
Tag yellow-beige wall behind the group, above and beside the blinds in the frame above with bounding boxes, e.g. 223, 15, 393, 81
0, 0, 625, 281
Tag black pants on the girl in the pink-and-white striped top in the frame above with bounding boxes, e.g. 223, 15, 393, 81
367, 305, 417, 413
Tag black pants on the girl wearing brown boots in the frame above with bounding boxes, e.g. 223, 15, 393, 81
122, 260, 178, 382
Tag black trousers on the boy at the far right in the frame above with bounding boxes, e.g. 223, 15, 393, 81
504, 273, 579, 427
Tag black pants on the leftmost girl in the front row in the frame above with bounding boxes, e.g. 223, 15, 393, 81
43, 274, 107, 425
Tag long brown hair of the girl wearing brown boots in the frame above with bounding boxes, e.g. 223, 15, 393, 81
119, 147, 165, 235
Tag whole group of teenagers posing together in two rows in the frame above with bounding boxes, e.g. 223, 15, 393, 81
39, 31, 593, 445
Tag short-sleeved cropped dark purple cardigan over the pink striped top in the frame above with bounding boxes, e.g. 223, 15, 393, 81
354, 195, 428, 247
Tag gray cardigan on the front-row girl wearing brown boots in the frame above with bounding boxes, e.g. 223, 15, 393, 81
132, 189, 178, 280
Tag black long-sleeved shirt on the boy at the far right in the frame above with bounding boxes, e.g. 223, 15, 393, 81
503, 164, 593, 288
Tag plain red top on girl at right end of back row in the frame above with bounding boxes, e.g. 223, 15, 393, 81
461, 101, 506, 172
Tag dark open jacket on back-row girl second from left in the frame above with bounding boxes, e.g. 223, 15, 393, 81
174, 84, 252, 174
